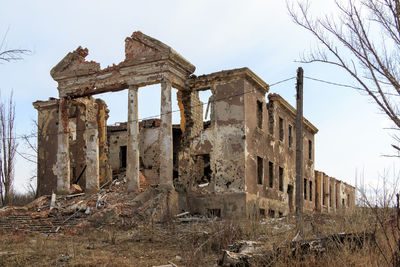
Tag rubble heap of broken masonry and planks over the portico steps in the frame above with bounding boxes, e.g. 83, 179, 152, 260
0, 175, 175, 234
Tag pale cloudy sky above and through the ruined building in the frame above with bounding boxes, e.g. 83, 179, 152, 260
0, 0, 396, 191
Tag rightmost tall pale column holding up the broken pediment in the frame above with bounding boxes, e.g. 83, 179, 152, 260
159, 80, 174, 189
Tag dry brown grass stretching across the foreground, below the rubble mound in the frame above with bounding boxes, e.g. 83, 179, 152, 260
0, 209, 395, 266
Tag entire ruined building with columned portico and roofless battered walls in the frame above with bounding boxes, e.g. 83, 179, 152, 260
33, 32, 355, 218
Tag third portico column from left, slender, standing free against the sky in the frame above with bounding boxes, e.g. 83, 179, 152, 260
126, 85, 140, 192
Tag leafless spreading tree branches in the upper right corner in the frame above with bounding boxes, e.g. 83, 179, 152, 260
287, 0, 400, 151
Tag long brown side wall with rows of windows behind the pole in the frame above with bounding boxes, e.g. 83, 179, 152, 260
245, 93, 316, 219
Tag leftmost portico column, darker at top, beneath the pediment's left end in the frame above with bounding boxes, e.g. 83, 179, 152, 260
57, 98, 70, 194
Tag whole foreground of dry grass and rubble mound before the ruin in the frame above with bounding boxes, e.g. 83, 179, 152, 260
0, 180, 394, 267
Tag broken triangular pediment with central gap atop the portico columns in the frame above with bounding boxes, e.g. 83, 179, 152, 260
50, 32, 195, 97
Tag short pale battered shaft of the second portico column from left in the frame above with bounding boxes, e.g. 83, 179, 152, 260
85, 118, 100, 193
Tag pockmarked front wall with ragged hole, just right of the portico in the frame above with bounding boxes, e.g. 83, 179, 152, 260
180, 78, 246, 217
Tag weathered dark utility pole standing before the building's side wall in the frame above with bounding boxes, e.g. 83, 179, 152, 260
296, 67, 304, 237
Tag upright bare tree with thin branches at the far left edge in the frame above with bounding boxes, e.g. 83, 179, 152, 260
0, 94, 17, 205
